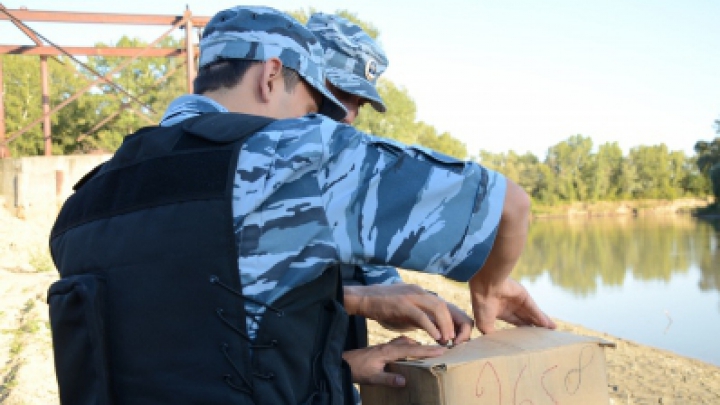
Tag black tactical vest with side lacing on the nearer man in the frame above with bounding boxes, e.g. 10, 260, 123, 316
48, 114, 349, 405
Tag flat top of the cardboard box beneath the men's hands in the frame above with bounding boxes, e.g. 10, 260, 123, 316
398, 327, 615, 371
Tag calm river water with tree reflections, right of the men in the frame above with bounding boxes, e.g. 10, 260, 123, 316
514, 216, 720, 366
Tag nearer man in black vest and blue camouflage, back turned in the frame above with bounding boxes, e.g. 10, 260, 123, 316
48, 7, 554, 405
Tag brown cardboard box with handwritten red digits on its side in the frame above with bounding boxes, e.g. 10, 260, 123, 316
361, 327, 614, 405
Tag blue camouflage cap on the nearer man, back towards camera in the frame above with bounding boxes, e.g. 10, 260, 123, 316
199, 6, 347, 120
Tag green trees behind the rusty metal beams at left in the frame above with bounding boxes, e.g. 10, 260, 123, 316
2, 37, 185, 156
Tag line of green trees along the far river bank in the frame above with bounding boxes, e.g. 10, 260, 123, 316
478, 135, 720, 205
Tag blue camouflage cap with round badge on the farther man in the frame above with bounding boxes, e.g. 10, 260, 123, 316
307, 13, 388, 112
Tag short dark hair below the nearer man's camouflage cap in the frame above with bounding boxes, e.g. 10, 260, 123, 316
193, 59, 300, 94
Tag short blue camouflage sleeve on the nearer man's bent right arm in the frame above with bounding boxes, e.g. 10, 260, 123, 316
319, 120, 506, 281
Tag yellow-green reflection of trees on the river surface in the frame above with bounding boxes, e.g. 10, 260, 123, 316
515, 216, 720, 297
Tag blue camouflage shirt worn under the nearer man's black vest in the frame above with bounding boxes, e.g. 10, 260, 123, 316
161, 95, 506, 336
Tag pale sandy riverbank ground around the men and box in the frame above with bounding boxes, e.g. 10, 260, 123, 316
0, 208, 720, 405
